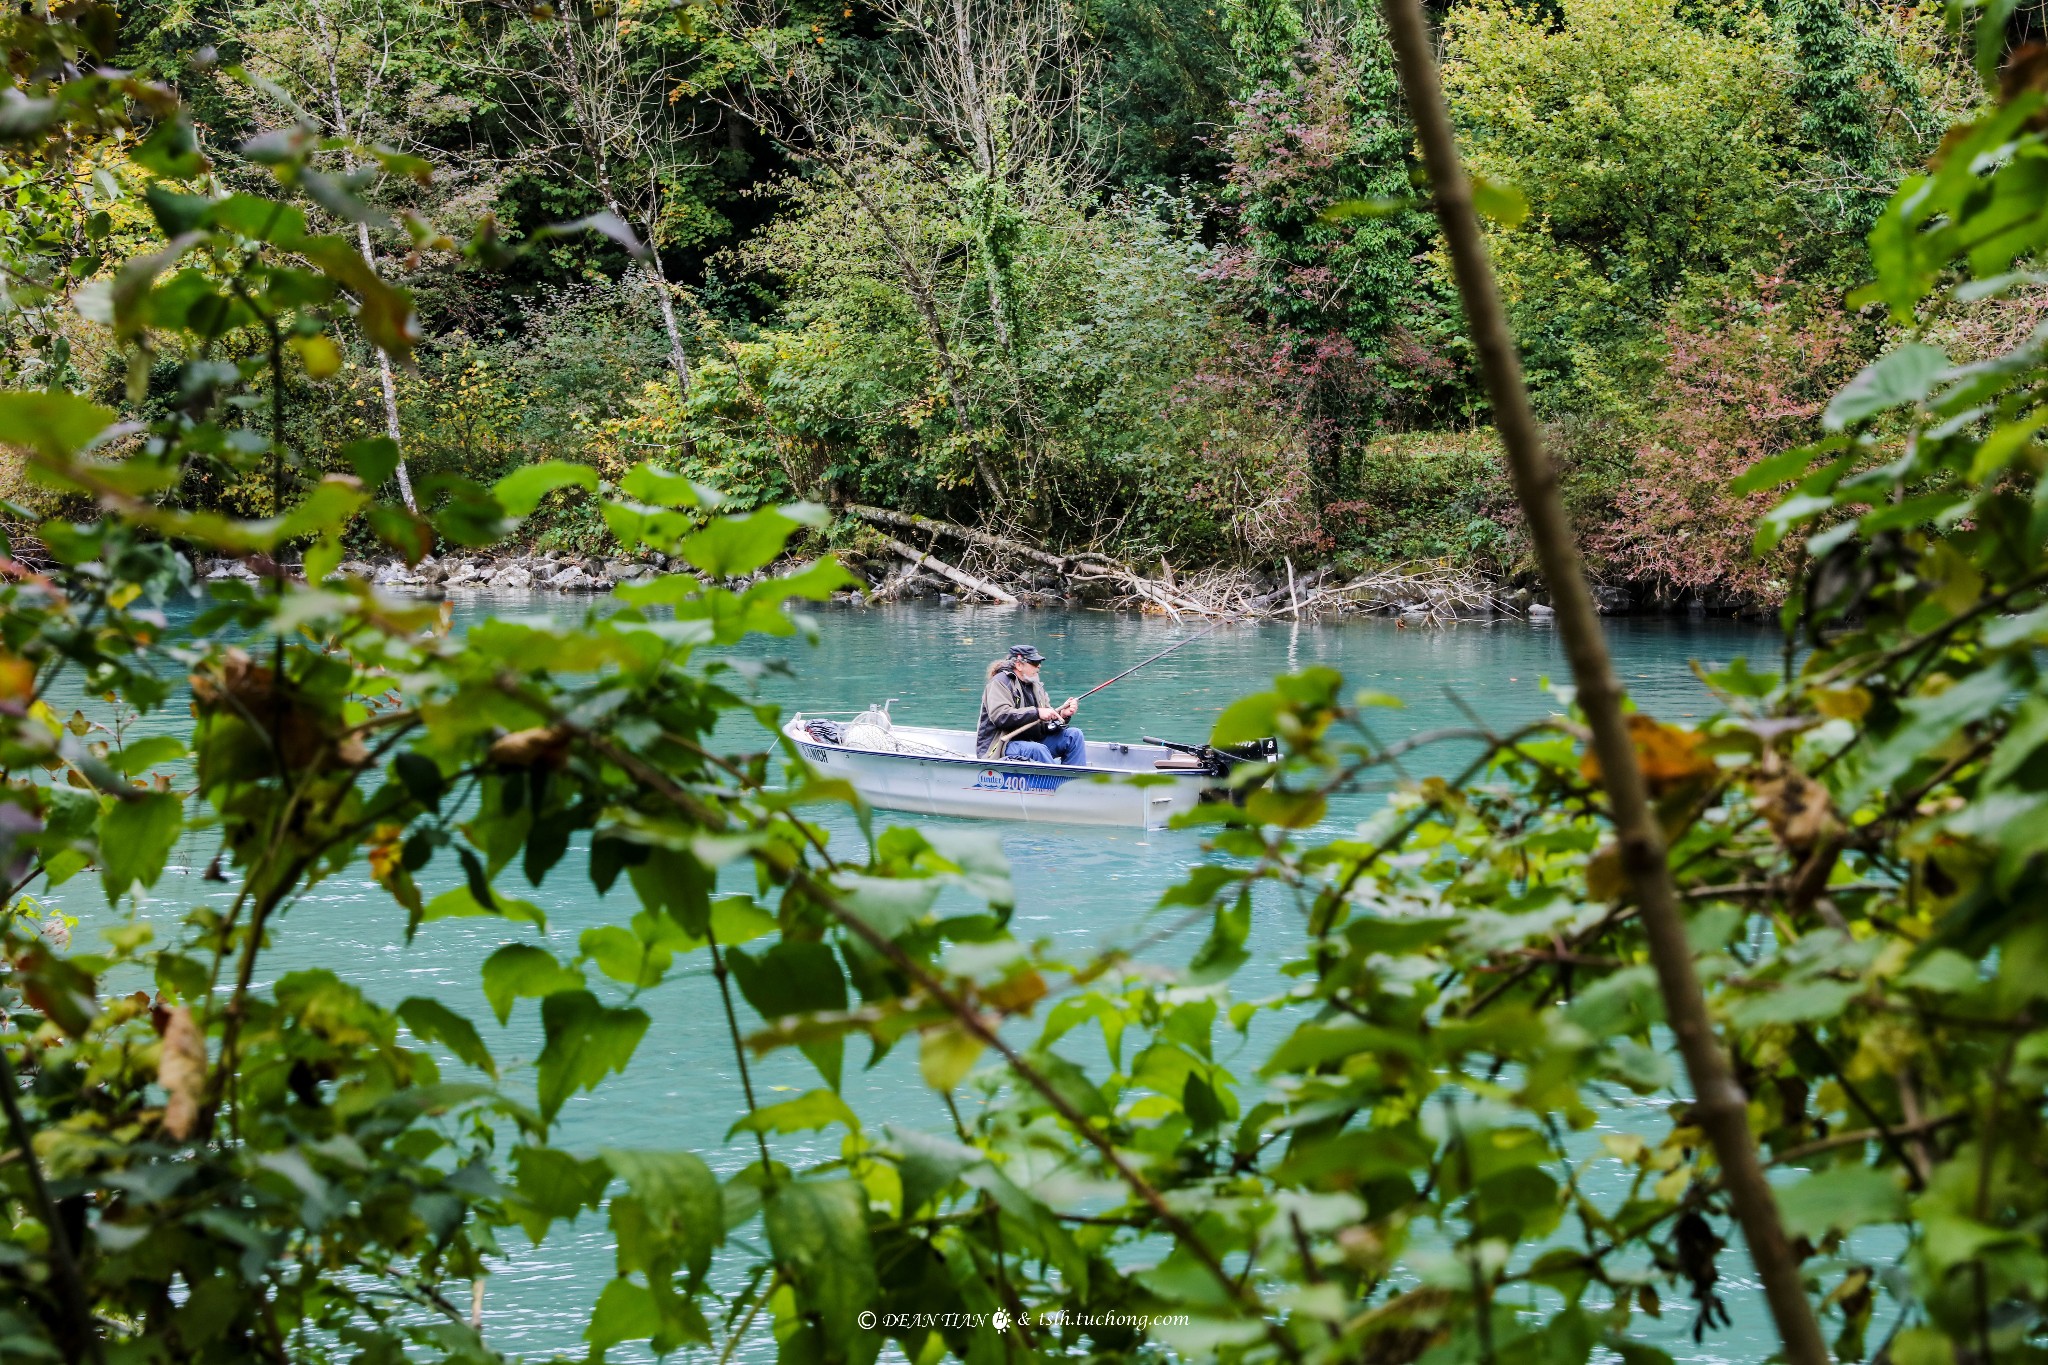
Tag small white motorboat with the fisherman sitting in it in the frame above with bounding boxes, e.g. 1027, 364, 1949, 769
782, 714, 1229, 829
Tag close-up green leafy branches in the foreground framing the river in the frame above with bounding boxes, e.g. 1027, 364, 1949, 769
0, 10, 2048, 1365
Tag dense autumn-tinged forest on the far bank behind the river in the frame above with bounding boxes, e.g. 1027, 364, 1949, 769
0, 0, 2042, 608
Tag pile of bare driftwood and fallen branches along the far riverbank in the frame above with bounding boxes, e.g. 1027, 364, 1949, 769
844, 503, 1544, 624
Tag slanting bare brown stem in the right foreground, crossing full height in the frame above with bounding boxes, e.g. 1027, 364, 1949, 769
1384, 0, 1829, 1365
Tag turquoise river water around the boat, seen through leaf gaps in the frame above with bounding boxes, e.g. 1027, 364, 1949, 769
51, 598, 1776, 1361
